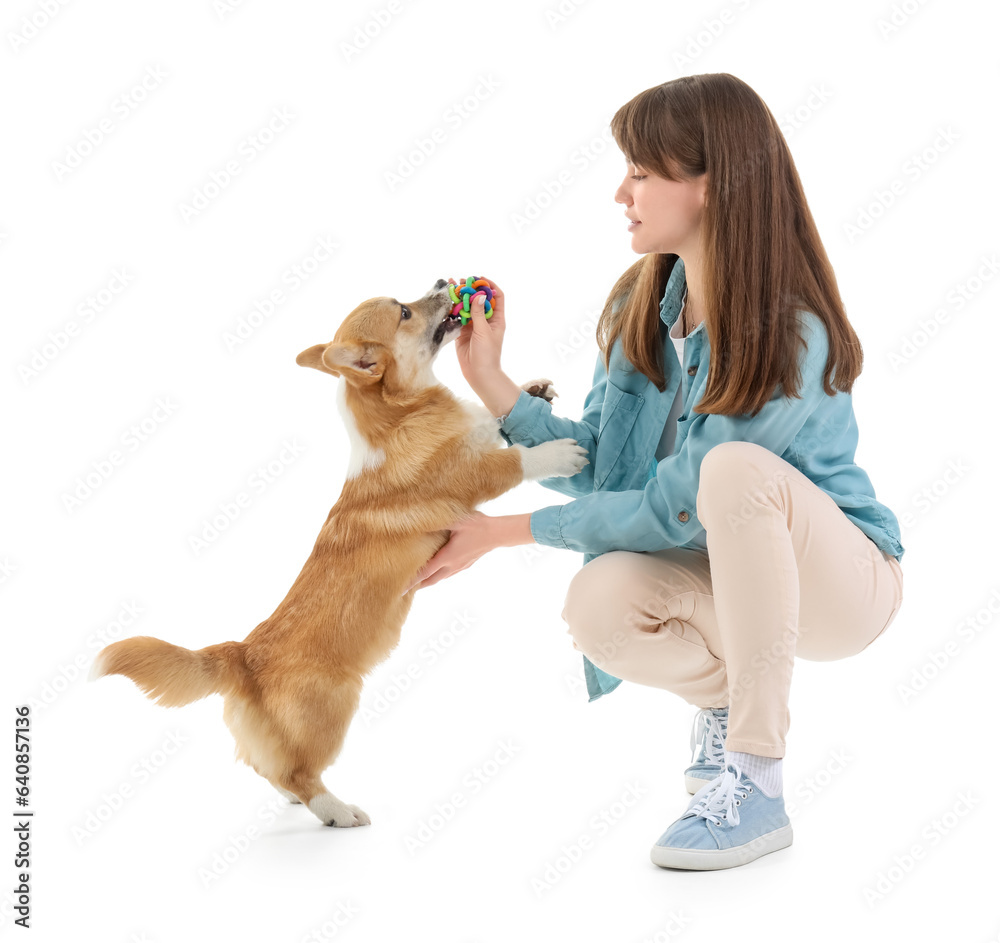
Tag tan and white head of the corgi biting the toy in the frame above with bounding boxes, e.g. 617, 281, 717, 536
295, 278, 462, 393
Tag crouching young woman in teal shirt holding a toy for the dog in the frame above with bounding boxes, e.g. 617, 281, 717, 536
400, 73, 903, 869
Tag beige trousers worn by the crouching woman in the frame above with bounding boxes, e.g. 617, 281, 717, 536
562, 442, 903, 757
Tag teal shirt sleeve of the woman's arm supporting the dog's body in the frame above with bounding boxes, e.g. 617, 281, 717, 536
529, 315, 829, 553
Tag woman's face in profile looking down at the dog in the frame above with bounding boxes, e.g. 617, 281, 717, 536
615, 162, 708, 258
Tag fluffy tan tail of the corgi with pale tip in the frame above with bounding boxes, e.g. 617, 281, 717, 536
90, 635, 247, 707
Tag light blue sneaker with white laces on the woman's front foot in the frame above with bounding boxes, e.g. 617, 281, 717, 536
649, 763, 792, 871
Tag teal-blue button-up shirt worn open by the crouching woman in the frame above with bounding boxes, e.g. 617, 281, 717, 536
500, 258, 904, 700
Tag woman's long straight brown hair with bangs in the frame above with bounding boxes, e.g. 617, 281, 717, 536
596, 72, 863, 415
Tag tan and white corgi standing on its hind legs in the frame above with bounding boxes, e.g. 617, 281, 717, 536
90, 279, 589, 827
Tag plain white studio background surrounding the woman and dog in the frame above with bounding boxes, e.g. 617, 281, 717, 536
0, 0, 1000, 943
